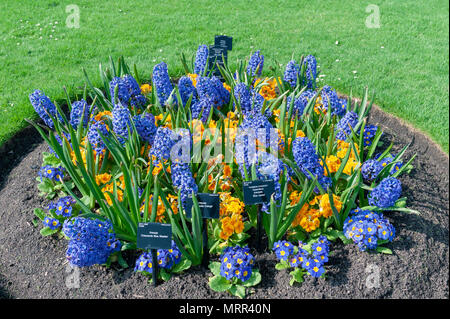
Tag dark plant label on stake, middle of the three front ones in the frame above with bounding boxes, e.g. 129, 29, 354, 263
186, 193, 220, 267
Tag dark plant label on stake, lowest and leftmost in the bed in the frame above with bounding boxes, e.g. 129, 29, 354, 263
136, 223, 172, 287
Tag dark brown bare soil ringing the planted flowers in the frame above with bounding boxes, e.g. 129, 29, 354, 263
0, 108, 449, 299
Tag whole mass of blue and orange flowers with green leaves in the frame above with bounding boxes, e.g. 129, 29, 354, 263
26, 46, 414, 297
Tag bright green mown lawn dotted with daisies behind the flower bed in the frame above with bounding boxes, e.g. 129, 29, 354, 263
0, 0, 449, 152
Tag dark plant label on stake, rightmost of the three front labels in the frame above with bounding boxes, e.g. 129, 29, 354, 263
243, 180, 275, 252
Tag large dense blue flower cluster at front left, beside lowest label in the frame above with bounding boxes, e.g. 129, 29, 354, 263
63, 217, 121, 267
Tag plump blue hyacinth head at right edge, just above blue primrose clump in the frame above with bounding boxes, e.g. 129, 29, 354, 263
368, 177, 402, 208
